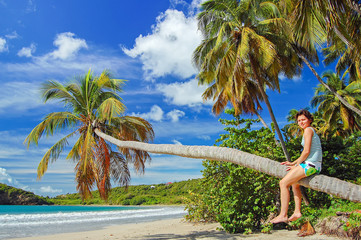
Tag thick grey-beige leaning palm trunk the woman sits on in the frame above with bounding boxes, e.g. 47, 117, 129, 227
94, 128, 361, 202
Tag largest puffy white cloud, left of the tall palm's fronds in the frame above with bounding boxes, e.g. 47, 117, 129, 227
123, 9, 201, 80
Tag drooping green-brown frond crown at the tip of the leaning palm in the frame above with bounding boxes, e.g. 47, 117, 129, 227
24, 70, 154, 199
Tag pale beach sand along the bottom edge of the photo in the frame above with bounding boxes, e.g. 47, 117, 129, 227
11, 218, 335, 240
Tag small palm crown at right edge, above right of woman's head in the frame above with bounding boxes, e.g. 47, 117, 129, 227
311, 71, 361, 137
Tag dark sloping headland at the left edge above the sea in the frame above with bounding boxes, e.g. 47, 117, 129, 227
0, 184, 52, 205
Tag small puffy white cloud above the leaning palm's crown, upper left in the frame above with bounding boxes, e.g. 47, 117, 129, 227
49, 32, 88, 60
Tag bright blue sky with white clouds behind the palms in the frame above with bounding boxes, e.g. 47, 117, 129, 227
0, 0, 330, 196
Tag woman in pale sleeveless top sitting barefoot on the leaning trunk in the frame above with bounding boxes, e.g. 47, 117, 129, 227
271, 110, 322, 224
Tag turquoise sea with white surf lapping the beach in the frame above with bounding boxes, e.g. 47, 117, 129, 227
0, 205, 186, 239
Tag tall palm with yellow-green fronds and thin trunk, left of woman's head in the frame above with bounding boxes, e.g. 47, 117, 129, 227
193, 0, 300, 159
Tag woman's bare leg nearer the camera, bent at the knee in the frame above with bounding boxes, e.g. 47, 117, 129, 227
271, 166, 306, 223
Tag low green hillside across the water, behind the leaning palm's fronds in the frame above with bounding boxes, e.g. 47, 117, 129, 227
52, 179, 200, 205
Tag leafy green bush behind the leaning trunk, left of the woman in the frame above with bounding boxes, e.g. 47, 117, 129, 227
188, 110, 284, 233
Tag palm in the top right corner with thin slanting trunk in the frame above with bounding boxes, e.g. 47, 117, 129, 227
281, 0, 361, 116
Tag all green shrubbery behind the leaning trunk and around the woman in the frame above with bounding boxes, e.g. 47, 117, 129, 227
186, 109, 361, 233
